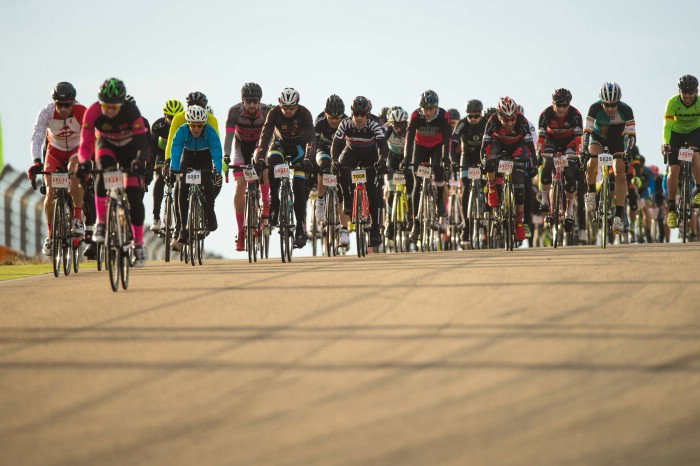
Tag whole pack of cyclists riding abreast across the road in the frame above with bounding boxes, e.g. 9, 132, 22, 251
28, 75, 700, 266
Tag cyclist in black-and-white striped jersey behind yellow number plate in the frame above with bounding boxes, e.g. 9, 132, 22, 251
331, 96, 389, 247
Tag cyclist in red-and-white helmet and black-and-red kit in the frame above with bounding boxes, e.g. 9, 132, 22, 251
481, 97, 537, 241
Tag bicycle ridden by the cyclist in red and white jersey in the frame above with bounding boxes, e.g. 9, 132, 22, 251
31, 171, 80, 278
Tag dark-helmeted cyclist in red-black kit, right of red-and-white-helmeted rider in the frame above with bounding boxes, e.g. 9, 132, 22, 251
537, 87, 583, 231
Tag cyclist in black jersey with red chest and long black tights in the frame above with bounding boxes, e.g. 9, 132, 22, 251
404, 89, 452, 242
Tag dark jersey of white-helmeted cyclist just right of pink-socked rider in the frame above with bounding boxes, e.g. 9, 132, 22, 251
258, 105, 316, 157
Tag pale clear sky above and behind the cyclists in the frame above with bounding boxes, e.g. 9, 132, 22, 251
0, 0, 700, 257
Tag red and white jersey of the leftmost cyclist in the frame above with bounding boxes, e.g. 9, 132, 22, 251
32, 102, 86, 160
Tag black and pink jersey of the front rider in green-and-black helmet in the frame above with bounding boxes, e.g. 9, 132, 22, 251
79, 102, 148, 163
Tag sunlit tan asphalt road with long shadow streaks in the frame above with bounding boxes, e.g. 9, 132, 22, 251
0, 243, 700, 466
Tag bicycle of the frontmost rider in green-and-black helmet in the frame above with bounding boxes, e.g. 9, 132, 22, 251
91, 165, 134, 292
